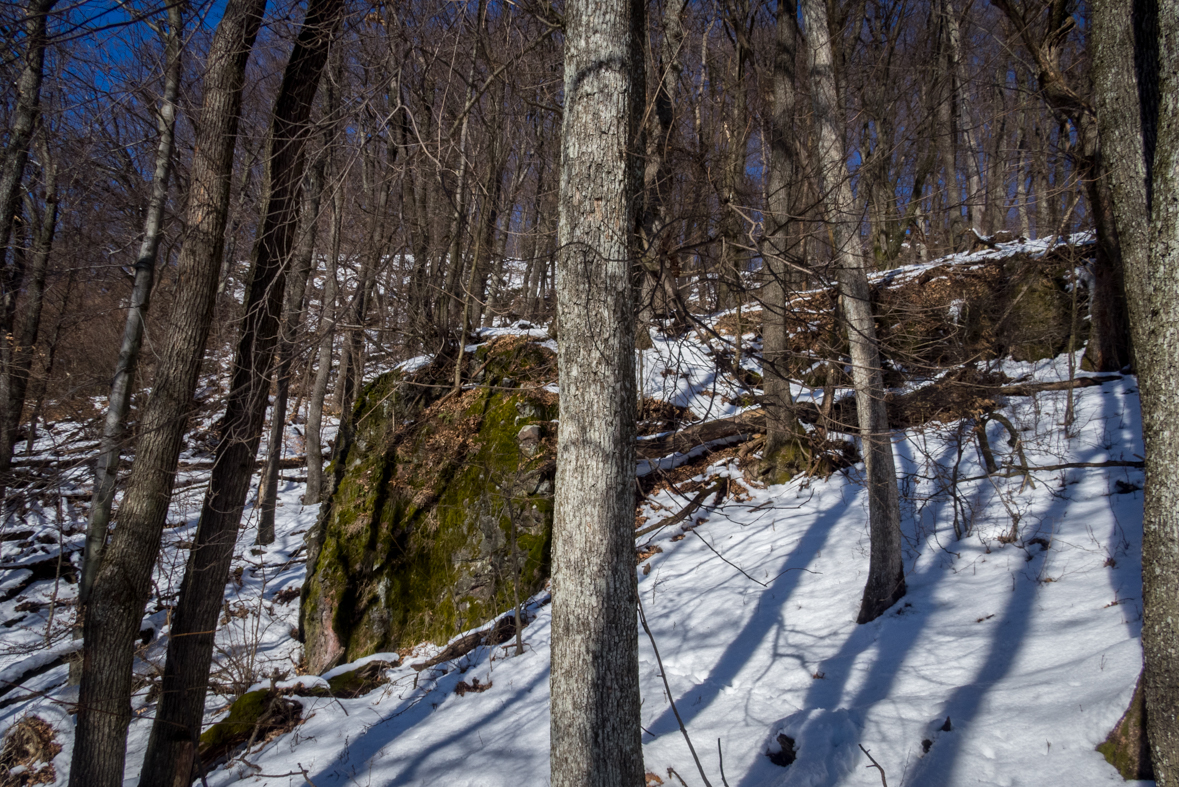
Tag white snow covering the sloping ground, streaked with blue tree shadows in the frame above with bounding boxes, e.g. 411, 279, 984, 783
0, 250, 1142, 787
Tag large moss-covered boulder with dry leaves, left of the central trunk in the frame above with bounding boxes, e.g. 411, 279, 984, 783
301, 337, 558, 672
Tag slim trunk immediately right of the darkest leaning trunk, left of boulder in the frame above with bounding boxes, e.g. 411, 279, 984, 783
256, 147, 324, 544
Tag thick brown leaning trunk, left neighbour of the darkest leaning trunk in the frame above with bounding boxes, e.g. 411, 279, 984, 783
70, 0, 265, 787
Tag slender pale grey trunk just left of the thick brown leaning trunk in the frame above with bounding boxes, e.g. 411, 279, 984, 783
78, 4, 184, 622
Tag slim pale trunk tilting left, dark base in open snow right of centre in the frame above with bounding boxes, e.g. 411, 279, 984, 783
802, 0, 904, 623
